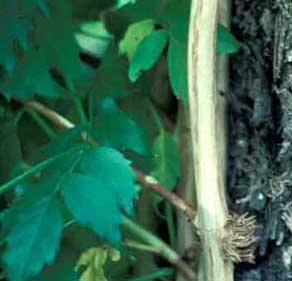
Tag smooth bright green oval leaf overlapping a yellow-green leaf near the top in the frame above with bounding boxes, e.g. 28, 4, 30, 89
129, 30, 168, 81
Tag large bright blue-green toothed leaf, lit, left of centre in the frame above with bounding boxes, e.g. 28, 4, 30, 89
61, 147, 137, 245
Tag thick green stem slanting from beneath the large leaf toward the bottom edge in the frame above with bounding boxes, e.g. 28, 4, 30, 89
122, 216, 196, 280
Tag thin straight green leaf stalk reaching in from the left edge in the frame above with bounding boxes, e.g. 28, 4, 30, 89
0, 147, 81, 195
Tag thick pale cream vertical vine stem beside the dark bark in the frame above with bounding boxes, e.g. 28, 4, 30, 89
188, 0, 233, 281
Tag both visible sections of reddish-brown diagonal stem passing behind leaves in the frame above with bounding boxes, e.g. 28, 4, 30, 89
24, 101, 196, 221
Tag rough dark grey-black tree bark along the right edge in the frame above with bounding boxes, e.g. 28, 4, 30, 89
230, 0, 292, 281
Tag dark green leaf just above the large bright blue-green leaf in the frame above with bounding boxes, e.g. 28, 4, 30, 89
93, 98, 147, 155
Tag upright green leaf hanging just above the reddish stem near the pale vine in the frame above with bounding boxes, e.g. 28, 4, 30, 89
152, 129, 180, 190
